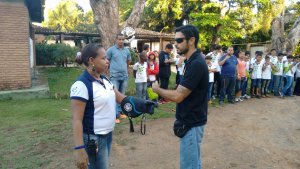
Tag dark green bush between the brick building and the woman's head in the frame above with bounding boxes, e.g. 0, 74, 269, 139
35, 43, 79, 66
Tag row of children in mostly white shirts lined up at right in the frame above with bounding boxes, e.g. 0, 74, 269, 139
205, 50, 300, 103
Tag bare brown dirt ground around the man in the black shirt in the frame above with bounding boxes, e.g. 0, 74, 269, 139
110, 97, 300, 169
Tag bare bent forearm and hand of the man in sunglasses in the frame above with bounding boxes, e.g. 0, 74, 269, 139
152, 82, 192, 103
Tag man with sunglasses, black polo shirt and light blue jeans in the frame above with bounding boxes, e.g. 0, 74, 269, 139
152, 25, 208, 169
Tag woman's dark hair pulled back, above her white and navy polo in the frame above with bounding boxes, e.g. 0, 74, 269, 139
75, 43, 103, 66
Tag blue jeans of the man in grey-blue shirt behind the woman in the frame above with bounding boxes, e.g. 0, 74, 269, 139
110, 77, 128, 118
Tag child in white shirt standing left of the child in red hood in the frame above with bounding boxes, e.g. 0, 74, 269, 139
133, 52, 148, 99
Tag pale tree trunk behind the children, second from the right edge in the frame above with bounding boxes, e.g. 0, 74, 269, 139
271, 13, 286, 52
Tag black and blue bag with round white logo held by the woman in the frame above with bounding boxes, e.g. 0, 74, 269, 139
121, 96, 158, 118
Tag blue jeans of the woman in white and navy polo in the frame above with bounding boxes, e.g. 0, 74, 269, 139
83, 132, 112, 169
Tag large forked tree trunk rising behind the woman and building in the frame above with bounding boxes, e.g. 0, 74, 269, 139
90, 0, 146, 48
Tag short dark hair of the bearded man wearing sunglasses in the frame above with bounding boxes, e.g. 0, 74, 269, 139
175, 25, 199, 48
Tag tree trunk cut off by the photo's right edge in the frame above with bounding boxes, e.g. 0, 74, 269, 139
286, 17, 300, 51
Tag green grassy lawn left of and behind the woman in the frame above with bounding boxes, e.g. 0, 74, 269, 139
0, 68, 175, 169
